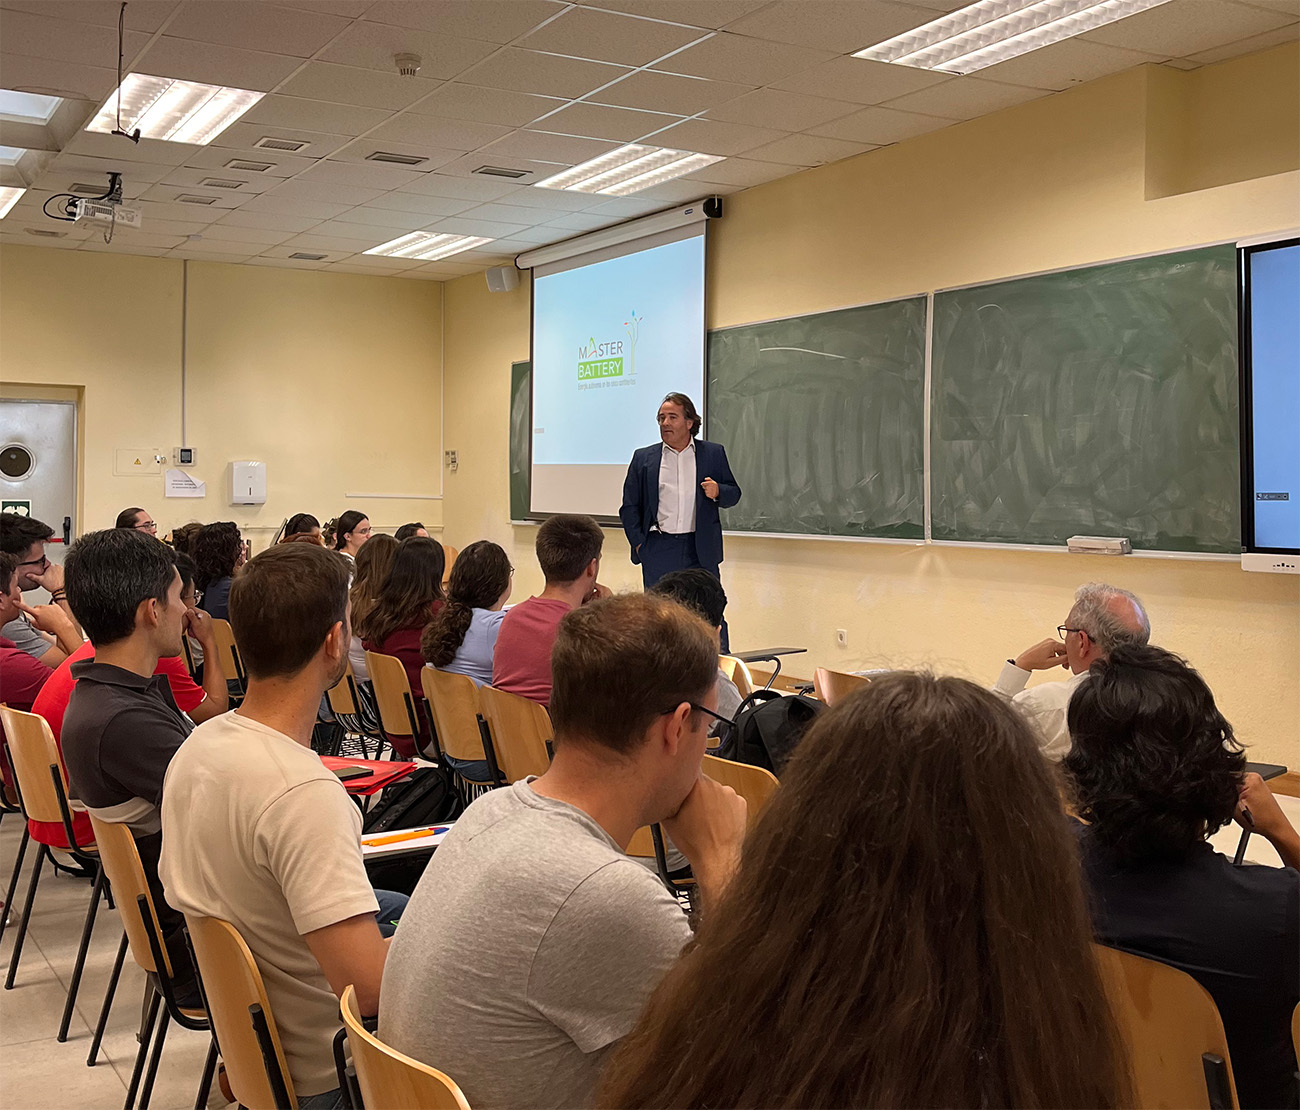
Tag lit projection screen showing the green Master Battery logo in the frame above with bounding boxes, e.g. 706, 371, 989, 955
532, 233, 705, 516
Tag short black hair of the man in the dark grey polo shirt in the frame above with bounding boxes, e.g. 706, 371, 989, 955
64, 528, 177, 647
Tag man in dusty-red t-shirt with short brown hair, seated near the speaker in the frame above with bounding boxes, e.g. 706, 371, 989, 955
491, 513, 610, 706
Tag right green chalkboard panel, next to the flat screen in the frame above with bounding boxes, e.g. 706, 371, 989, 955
931, 246, 1240, 551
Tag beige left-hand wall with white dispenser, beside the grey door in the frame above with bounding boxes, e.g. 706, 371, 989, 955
0, 246, 442, 547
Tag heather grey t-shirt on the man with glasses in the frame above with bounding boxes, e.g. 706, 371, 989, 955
380, 779, 690, 1110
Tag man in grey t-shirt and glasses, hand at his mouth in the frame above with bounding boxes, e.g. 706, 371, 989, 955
380, 600, 753, 1110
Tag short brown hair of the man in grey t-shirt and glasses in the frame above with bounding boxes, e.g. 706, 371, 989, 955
550, 594, 718, 755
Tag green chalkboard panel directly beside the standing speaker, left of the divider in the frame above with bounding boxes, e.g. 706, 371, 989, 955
707, 296, 926, 539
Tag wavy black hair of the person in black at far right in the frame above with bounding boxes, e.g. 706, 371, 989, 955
1063, 645, 1245, 866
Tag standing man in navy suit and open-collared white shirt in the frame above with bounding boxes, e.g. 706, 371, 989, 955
619, 393, 740, 626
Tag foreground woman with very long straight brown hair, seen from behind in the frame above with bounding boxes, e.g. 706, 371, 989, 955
597, 673, 1130, 1107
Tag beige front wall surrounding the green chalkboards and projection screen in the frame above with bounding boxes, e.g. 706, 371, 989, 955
445, 47, 1300, 766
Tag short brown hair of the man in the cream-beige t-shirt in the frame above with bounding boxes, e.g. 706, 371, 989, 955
230, 543, 351, 678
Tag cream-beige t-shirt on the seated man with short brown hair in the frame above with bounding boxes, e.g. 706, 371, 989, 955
159, 712, 378, 1096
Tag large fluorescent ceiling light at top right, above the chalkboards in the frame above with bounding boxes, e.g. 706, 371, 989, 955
854, 0, 1169, 73
